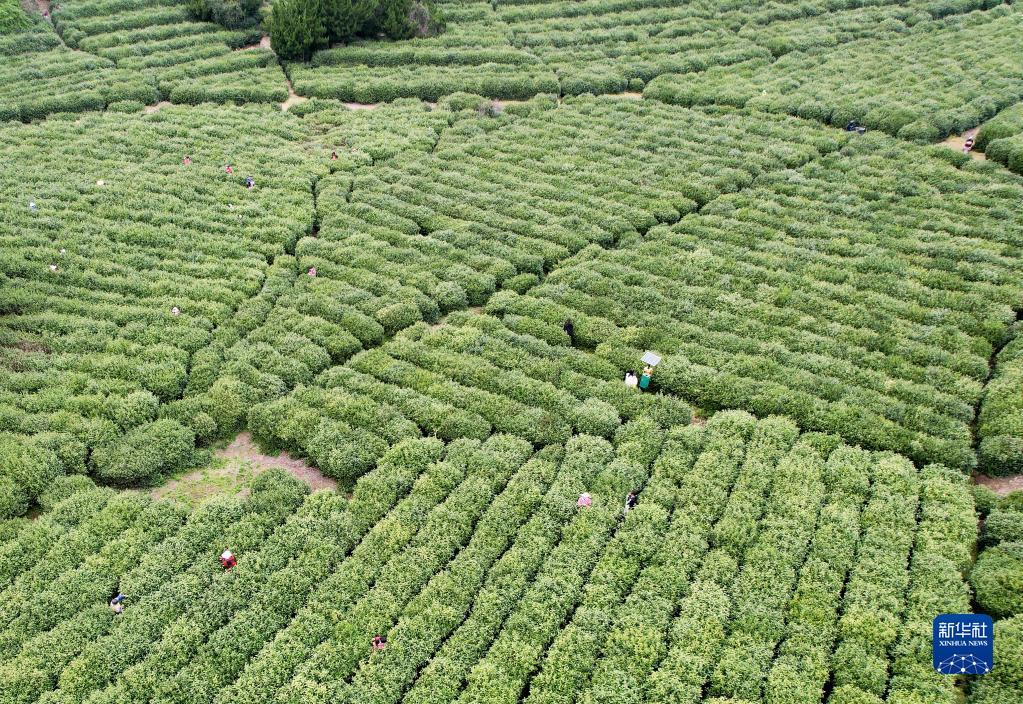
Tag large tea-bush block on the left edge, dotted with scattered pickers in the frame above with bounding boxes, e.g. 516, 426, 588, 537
0, 107, 327, 508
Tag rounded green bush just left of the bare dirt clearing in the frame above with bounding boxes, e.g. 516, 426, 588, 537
92, 420, 195, 485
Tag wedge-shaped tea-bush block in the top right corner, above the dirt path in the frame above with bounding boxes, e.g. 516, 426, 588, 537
643, 4, 1023, 142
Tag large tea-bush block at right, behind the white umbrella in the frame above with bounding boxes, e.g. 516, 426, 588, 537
487, 129, 1023, 469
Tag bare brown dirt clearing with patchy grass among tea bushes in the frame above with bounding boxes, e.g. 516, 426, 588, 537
152, 433, 338, 503
